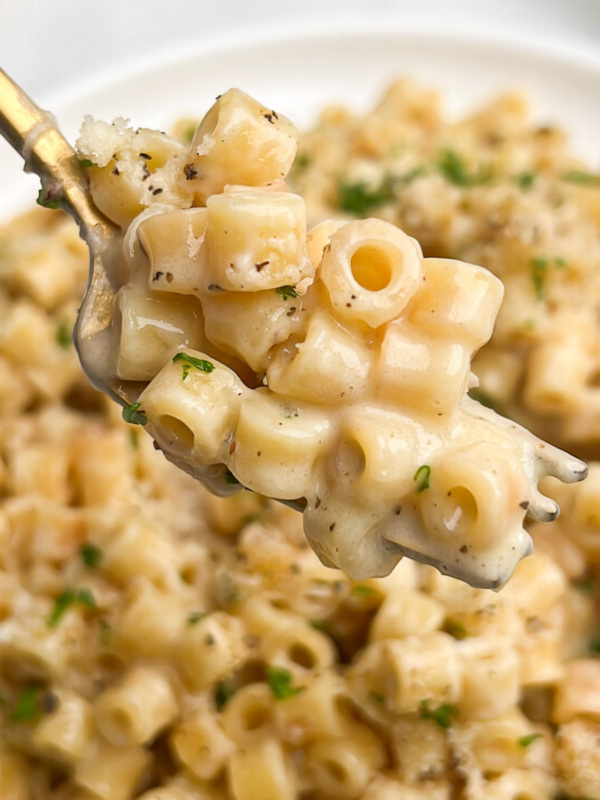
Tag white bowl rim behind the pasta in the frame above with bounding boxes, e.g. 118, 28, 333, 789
0, 29, 600, 219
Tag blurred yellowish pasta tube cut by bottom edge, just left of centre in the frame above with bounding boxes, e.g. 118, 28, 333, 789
227, 739, 297, 800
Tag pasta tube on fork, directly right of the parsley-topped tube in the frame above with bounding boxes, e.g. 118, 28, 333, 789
230, 389, 333, 500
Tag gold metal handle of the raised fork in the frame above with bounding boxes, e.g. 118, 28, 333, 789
0, 69, 113, 241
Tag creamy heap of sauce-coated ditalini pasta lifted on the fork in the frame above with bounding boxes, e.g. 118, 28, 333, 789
77, 89, 586, 588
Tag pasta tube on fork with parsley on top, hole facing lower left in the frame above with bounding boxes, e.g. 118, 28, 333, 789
140, 350, 244, 464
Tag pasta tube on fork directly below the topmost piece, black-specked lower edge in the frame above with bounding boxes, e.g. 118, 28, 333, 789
204, 191, 314, 292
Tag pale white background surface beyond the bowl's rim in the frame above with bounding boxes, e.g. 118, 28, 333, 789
0, 0, 600, 102
